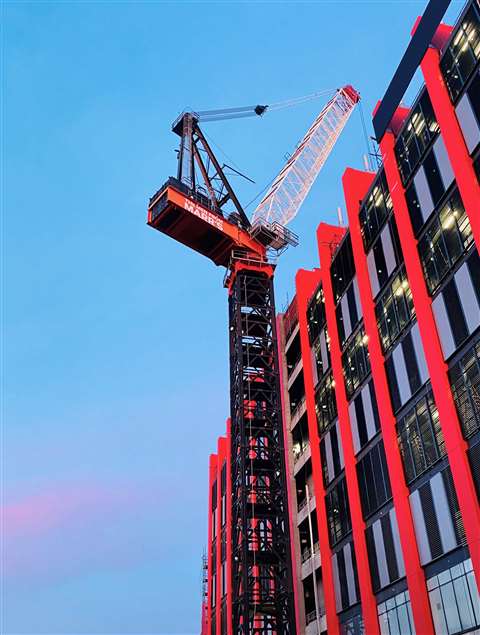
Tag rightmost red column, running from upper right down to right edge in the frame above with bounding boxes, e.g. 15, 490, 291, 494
420, 40, 480, 249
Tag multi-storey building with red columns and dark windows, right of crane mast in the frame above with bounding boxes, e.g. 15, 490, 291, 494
202, 0, 480, 635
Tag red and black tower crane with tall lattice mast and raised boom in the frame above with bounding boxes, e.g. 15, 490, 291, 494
148, 86, 360, 635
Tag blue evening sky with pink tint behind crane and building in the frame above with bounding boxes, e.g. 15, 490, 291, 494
2, 0, 463, 635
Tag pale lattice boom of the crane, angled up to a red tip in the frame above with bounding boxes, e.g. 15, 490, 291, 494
252, 86, 360, 225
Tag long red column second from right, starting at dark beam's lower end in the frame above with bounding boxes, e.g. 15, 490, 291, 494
380, 132, 480, 585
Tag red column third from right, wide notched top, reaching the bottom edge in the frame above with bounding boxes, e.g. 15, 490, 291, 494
343, 168, 434, 633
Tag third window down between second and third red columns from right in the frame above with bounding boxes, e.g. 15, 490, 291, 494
397, 392, 445, 483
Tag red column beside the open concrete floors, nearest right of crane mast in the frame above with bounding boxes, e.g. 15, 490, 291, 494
295, 269, 340, 635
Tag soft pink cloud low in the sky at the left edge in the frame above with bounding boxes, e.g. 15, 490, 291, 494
2, 483, 172, 580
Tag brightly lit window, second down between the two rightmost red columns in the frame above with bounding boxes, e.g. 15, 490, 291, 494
418, 192, 473, 294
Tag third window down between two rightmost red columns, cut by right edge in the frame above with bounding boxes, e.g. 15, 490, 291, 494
449, 341, 480, 439
